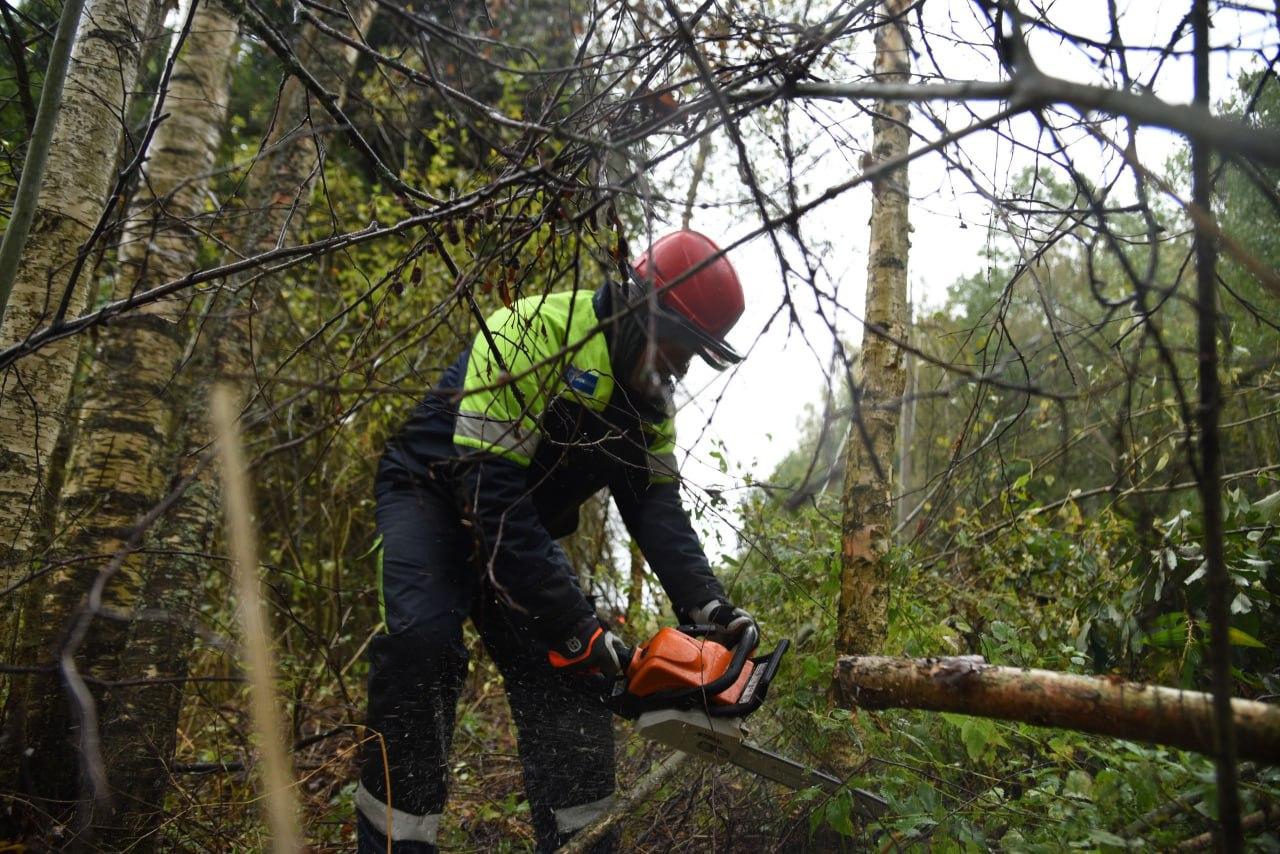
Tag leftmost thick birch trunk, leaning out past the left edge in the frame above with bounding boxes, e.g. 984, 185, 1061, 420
0, 0, 159, 568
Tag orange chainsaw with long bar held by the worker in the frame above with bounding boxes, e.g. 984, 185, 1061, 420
604, 625, 887, 818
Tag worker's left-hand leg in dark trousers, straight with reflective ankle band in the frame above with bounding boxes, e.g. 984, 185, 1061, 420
356, 484, 475, 854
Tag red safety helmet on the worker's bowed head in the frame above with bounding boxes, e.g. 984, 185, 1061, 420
632, 230, 746, 370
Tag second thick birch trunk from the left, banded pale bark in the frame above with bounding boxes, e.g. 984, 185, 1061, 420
5, 0, 237, 826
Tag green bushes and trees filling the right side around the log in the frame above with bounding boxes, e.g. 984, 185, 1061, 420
733, 83, 1280, 851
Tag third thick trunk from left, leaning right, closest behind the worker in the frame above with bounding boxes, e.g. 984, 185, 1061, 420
99, 10, 374, 850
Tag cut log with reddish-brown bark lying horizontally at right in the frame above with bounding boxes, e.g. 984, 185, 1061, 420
835, 656, 1280, 764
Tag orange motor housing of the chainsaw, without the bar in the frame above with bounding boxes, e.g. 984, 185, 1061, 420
627, 626, 755, 705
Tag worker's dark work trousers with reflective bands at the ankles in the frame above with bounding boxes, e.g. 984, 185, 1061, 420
356, 481, 616, 854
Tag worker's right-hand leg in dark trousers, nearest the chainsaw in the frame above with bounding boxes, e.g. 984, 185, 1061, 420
474, 594, 617, 851
